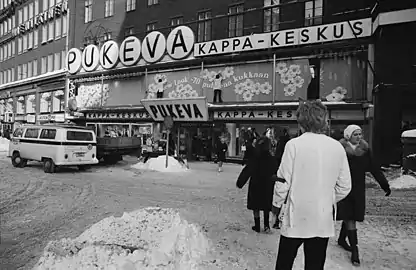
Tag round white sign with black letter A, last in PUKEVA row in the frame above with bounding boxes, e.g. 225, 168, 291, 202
166, 26, 195, 60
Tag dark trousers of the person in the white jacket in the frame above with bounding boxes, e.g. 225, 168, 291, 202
275, 235, 329, 270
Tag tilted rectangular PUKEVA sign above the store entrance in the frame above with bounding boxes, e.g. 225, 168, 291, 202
141, 97, 208, 122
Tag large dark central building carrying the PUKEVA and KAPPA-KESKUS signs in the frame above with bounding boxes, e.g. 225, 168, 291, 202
67, 0, 412, 162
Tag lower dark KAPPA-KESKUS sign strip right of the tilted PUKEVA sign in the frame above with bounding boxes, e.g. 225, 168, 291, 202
214, 110, 296, 120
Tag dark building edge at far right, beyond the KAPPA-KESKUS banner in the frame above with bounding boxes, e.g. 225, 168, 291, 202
372, 0, 416, 164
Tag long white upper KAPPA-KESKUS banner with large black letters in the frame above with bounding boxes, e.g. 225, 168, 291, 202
194, 18, 372, 57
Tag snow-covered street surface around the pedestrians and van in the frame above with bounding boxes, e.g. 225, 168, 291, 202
0, 155, 416, 270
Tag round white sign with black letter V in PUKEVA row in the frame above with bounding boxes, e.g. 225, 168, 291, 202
142, 31, 166, 63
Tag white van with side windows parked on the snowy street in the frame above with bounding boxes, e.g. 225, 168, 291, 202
9, 124, 98, 173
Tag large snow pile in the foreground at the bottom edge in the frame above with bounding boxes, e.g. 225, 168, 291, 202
35, 208, 210, 270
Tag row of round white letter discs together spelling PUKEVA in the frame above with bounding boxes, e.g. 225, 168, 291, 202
66, 26, 195, 74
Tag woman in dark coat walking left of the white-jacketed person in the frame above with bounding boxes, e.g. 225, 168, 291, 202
237, 137, 278, 232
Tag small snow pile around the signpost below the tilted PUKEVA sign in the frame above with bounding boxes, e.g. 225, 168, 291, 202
132, 156, 188, 172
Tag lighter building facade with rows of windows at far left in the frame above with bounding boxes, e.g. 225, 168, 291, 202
0, 0, 69, 133
